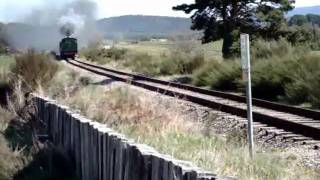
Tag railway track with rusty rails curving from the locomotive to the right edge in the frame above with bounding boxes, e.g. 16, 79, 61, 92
68, 60, 320, 144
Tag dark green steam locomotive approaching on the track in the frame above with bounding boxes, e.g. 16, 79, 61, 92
59, 36, 78, 60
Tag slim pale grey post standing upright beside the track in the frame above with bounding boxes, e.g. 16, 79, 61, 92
240, 34, 254, 158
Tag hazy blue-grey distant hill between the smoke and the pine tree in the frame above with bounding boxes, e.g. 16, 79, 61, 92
97, 15, 194, 39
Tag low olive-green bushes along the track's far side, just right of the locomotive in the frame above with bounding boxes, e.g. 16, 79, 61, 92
81, 43, 205, 76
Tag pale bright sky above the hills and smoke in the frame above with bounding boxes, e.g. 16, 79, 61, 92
0, 0, 320, 22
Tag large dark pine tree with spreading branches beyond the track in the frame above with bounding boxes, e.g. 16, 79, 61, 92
173, 0, 294, 58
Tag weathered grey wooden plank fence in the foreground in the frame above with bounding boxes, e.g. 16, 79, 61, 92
33, 95, 231, 180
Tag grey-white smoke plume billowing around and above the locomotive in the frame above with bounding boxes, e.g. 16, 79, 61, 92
6, 0, 99, 51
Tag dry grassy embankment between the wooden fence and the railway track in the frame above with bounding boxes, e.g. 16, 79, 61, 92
1, 52, 319, 179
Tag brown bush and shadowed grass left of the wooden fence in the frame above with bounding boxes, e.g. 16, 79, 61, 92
0, 52, 75, 180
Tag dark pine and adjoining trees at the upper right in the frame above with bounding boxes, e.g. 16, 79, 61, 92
173, 0, 320, 58
